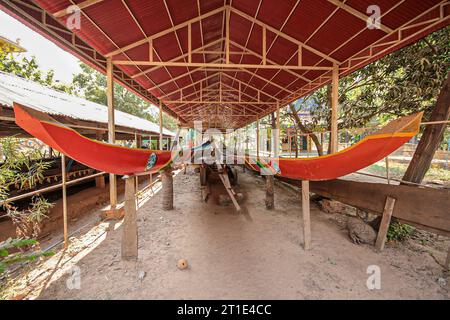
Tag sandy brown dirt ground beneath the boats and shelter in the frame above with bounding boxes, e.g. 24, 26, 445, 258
3, 169, 450, 299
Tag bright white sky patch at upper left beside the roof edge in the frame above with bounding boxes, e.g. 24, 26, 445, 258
0, 10, 81, 83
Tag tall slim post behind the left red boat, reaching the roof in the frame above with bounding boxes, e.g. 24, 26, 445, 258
106, 58, 117, 210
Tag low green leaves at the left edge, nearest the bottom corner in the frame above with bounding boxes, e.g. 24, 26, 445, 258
0, 238, 54, 274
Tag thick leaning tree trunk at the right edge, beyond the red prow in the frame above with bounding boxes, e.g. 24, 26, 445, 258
403, 73, 450, 183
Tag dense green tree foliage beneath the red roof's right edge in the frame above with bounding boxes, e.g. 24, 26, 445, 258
290, 27, 450, 130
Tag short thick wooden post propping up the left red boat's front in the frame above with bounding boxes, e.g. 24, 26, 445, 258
122, 176, 138, 260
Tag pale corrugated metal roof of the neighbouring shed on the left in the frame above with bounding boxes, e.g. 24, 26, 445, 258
0, 72, 175, 136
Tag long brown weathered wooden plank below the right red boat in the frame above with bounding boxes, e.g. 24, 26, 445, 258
302, 179, 450, 236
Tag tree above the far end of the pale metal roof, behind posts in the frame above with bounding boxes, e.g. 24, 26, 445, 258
72, 63, 177, 130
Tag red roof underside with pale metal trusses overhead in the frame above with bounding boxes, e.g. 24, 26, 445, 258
0, 0, 450, 129
